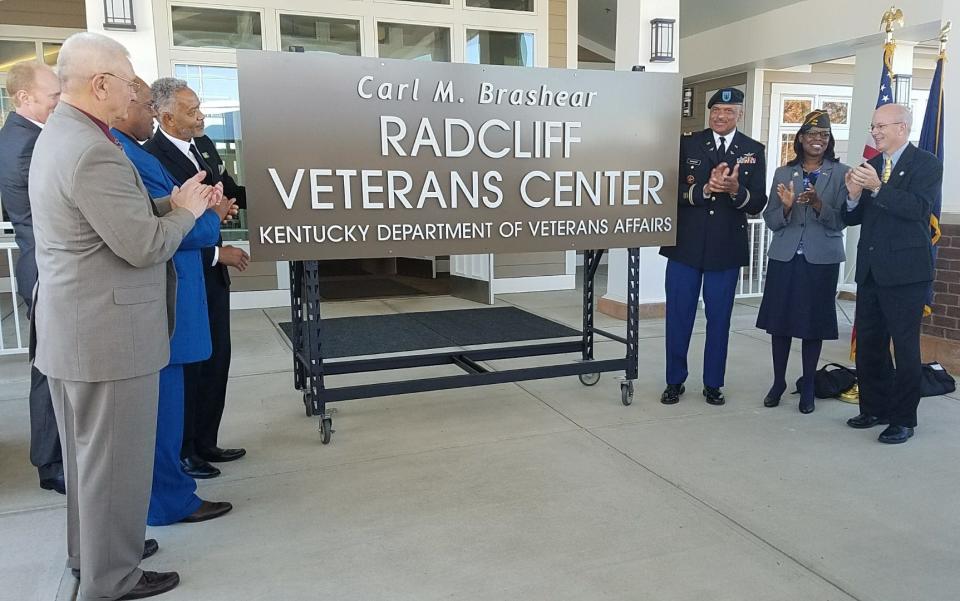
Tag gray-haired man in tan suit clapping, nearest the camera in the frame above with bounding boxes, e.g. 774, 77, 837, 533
30, 32, 219, 601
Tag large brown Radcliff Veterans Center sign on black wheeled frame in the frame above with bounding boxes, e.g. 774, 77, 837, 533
237, 50, 680, 261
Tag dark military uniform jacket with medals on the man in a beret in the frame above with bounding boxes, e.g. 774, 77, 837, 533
660, 129, 767, 271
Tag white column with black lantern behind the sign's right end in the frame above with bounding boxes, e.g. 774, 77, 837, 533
603, 0, 680, 304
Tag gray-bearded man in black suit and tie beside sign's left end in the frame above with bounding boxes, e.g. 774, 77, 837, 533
143, 77, 250, 478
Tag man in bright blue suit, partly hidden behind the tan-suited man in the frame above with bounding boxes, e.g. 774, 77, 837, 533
112, 78, 235, 526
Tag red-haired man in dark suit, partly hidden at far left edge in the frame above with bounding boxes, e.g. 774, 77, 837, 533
0, 61, 66, 494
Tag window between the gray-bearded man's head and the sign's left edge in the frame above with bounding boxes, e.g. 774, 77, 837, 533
174, 65, 247, 241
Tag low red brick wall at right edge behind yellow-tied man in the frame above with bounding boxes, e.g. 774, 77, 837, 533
923, 225, 960, 341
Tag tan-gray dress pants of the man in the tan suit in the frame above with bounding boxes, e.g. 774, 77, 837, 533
47, 373, 159, 601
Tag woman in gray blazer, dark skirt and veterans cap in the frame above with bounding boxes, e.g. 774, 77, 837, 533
757, 111, 849, 413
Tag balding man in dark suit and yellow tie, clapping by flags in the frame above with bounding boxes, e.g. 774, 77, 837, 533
843, 104, 943, 444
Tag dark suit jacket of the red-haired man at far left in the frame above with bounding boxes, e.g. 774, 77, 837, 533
0, 113, 41, 306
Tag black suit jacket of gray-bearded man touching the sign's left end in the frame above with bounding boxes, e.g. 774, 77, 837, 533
143, 129, 247, 286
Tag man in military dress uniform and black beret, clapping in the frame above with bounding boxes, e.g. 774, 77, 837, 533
660, 88, 767, 405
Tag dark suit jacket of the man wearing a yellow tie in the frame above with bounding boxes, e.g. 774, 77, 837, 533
843, 144, 943, 286
